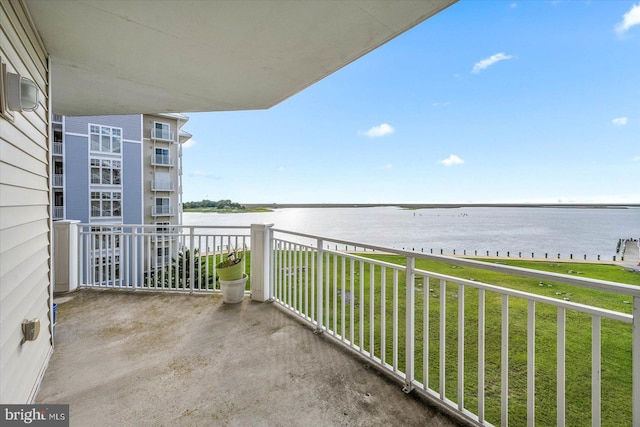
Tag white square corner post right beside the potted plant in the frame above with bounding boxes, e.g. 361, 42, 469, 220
250, 224, 273, 302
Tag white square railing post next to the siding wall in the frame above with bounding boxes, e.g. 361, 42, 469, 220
53, 220, 80, 292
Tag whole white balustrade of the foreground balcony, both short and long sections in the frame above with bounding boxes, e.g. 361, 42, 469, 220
69, 225, 640, 426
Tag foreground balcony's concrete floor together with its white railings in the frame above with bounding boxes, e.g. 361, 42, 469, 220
47, 225, 640, 425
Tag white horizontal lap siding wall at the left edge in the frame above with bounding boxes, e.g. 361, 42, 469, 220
0, 0, 52, 403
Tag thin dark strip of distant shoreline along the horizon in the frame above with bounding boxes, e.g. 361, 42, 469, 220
243, 203, 640, 209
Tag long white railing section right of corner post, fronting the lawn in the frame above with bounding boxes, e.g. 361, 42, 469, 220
271, 229, 640, 426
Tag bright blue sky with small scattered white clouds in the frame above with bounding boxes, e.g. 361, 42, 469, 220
183, 0, 640, 203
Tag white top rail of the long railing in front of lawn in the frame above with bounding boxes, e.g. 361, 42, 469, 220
273, 228, 640, 297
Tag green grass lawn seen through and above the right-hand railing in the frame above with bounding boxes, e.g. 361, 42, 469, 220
280, 252, 640, 426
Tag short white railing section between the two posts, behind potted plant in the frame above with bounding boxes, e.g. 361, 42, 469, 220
78, 224, 250, 292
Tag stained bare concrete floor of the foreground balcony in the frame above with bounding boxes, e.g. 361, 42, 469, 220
36, 290, 455, 426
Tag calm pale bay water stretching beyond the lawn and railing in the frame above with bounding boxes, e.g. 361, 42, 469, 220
183, 207, 640, 260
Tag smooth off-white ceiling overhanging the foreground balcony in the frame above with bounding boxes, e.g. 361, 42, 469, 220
25, 0, 457, 115
